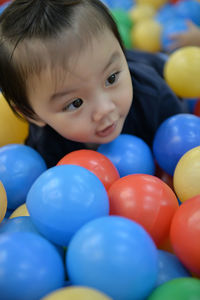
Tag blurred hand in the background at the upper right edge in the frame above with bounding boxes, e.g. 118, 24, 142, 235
169, 20, 200, 51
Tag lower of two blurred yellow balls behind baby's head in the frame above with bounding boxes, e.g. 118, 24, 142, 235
131, 19, 161, 52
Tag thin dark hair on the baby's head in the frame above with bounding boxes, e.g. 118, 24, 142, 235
0, 0, 124, 119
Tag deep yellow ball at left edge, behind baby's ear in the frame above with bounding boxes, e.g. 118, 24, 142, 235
0, 93, 28, 147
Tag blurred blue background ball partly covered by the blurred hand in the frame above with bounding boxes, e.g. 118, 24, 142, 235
161, 18, 188, 51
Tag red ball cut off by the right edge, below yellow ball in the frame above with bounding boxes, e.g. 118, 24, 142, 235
170, 195, 200, 276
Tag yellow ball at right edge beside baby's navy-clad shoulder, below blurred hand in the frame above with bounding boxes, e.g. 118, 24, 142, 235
164, 46, 200, 98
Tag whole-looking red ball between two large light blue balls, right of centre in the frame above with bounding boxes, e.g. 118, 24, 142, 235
108, 174, 178, 245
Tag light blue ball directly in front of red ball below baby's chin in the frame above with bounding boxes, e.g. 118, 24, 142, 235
26, 165, 109, 246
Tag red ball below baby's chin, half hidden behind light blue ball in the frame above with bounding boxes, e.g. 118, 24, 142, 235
57, 149, 120, 190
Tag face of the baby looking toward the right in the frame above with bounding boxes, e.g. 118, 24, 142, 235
28, 30, 133, 144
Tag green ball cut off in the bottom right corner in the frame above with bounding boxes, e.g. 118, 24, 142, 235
147, 277, 200, 300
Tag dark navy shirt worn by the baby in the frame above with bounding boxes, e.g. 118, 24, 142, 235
26, 50, 187, 167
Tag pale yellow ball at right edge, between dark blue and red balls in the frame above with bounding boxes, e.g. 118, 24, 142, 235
173, 146, 200, 202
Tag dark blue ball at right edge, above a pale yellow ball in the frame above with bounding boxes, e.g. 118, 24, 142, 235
153, 114, 200, 176
